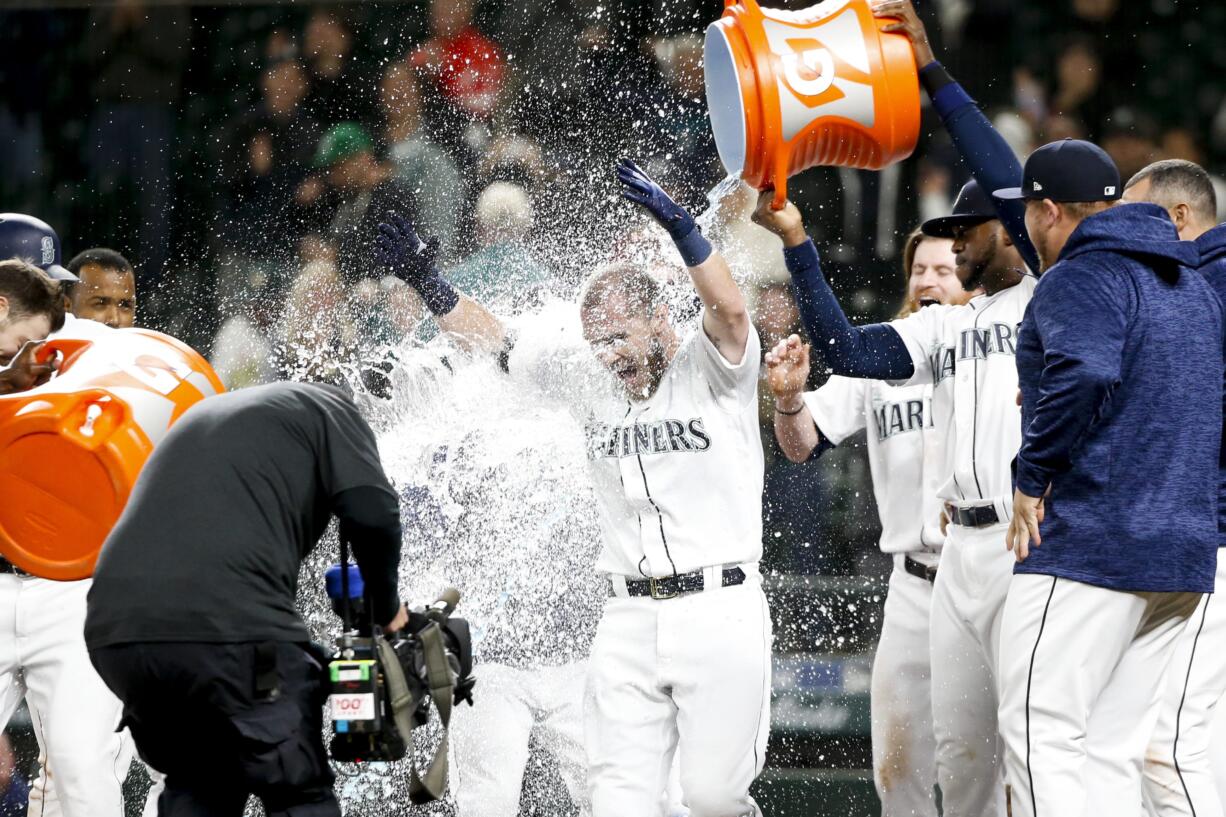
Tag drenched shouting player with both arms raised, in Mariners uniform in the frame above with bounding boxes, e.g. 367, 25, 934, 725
379, 161, 771, 817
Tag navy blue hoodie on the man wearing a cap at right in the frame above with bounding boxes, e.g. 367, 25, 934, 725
1015, 204, 1222, 593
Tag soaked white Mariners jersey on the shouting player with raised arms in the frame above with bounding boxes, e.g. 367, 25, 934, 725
509, 306, 764, 577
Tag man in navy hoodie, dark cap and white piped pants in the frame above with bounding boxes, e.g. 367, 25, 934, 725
996, 140, 1224, 817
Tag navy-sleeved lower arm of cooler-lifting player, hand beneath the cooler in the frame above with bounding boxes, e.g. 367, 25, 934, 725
754, 190, 915, 380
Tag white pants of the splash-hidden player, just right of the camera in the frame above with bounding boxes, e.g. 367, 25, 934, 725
450, 664, 591, 817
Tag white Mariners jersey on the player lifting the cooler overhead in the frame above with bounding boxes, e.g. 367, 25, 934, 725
890, 276, 1037, 519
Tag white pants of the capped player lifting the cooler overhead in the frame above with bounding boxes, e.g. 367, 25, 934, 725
931, 523, 1014, 817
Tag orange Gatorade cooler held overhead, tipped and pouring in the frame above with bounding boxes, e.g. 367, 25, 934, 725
704, 0, 920, 207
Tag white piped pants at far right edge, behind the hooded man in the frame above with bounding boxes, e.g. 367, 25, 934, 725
1145, 552, 1226, 817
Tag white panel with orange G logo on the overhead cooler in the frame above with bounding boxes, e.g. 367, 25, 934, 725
763, 7, 877, 141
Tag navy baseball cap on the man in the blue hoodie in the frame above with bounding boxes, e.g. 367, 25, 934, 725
992, 139, 1124, 201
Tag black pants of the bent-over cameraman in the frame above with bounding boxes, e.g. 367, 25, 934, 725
89, 643, 341, 817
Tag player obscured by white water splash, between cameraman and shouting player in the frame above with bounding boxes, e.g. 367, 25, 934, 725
392, 402, 607, 817
